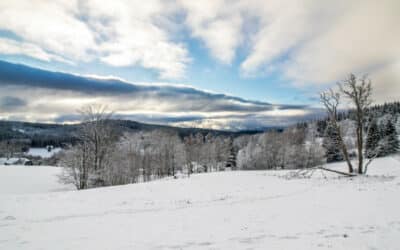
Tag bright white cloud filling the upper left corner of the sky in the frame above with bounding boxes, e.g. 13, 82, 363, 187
0, 0, 96, 60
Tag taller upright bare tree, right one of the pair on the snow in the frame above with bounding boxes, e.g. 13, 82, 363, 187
339, 74, 372, 174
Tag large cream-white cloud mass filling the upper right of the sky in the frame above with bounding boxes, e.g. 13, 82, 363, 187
181, 0, 400, 102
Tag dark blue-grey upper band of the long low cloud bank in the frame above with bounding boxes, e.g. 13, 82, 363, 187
0, 61, 304, 112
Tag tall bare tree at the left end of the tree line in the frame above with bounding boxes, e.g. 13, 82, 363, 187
61, 105, 118, 189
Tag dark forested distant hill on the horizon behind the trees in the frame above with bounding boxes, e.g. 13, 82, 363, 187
0, 120, 271, 147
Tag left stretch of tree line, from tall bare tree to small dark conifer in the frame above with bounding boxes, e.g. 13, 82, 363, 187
59, 106, 232, 189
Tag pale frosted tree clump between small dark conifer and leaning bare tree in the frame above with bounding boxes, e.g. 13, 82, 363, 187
237, 126, 323, 169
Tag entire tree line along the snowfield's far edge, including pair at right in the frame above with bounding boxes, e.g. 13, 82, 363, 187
59, 75, 400, 189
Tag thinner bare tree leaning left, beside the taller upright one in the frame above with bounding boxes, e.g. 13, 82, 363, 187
320, 89, 354, 173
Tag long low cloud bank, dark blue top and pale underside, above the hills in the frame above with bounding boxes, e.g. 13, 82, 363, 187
0, 61, 316, 130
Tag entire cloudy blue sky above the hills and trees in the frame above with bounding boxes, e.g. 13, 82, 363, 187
0, 0, 400, 130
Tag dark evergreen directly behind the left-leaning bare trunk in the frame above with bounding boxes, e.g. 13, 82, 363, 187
322, 122, 343, 162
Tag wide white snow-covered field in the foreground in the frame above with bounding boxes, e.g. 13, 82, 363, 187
0, 157, 400, 250
